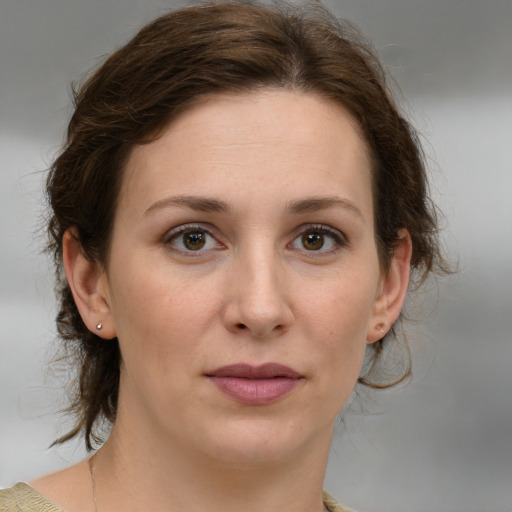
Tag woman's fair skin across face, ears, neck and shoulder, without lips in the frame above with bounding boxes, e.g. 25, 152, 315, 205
33, 90, 411, 512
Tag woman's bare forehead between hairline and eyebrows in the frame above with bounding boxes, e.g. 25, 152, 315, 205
120, 89, 371, 220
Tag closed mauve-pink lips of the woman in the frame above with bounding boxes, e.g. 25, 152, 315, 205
207, 363, 303, 405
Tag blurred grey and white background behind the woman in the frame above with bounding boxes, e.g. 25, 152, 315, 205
0, 0, 512, 512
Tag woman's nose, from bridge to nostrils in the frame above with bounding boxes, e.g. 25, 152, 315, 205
223, 248, 293, 339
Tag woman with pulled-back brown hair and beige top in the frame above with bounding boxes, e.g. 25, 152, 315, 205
0, 2, 443, 512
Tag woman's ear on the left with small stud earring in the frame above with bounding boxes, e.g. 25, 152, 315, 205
62, 229, 117, 339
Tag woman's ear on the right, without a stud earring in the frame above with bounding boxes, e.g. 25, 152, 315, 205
366, 229, 412, 343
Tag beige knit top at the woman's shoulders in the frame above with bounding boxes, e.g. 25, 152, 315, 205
0, 483, 351, 512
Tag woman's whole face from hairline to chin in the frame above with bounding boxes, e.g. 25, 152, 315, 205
102, 90, 404, 461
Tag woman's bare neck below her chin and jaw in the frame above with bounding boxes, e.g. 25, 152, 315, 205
94, 418, 330, 512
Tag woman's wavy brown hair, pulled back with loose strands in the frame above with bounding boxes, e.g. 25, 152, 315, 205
47, 2, 444, 449
